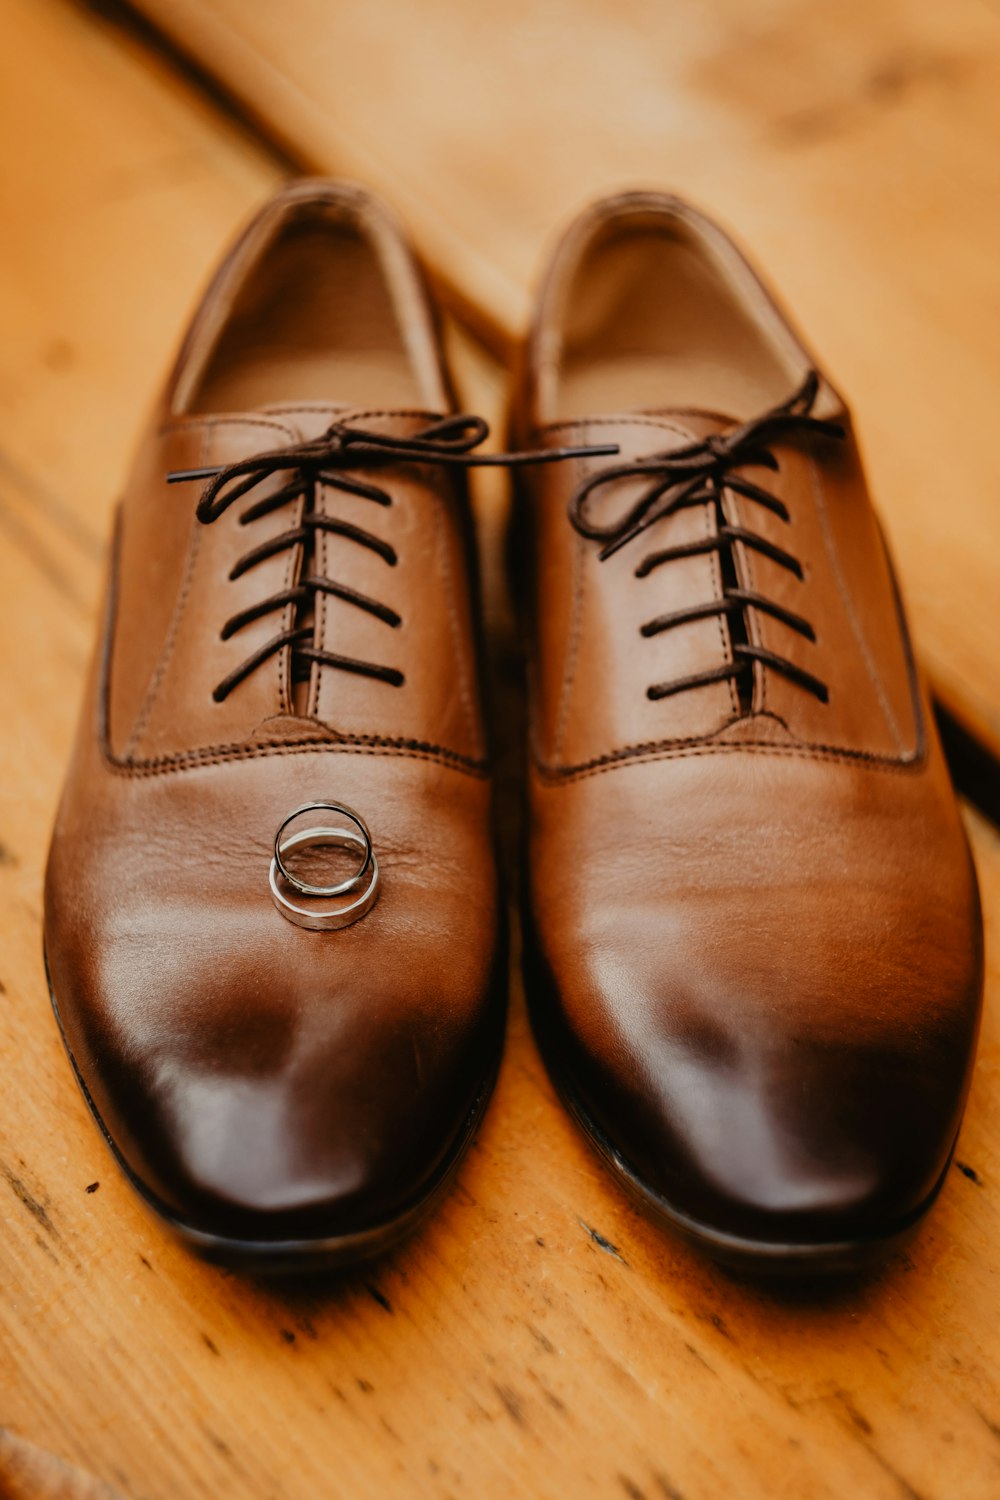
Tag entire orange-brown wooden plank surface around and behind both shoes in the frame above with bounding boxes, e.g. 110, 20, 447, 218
0, 0, 1000, 1500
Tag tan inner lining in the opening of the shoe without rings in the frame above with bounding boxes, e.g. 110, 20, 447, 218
540, 212, 807, 420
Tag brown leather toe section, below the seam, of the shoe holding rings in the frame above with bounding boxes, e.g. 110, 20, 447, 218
48, 752, 504, 1241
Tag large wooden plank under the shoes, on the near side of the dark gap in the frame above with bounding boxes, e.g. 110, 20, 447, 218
0, 0, 1000, 1500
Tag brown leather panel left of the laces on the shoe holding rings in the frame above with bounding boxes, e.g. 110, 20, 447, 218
108, 417, 301, 762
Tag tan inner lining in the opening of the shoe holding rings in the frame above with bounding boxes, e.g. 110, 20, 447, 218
183, 203, 441, 413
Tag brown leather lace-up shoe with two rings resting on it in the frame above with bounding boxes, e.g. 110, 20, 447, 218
45, 183, 504, 1268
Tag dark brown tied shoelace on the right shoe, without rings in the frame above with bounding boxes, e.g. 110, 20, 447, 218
570, 371, 844, 710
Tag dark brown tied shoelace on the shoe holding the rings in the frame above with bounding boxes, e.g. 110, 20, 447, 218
166, 413, 619, 702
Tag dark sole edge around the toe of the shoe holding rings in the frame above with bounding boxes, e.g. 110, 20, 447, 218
43, 954, 505, 1277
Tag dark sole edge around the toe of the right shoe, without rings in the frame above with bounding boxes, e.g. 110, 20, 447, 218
522, 914, 955, 1281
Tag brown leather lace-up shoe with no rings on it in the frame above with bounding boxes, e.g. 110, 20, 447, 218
516, 194, 982, 1269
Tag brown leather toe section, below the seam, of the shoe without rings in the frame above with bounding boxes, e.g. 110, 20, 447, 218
528, 755, 982, 1245
